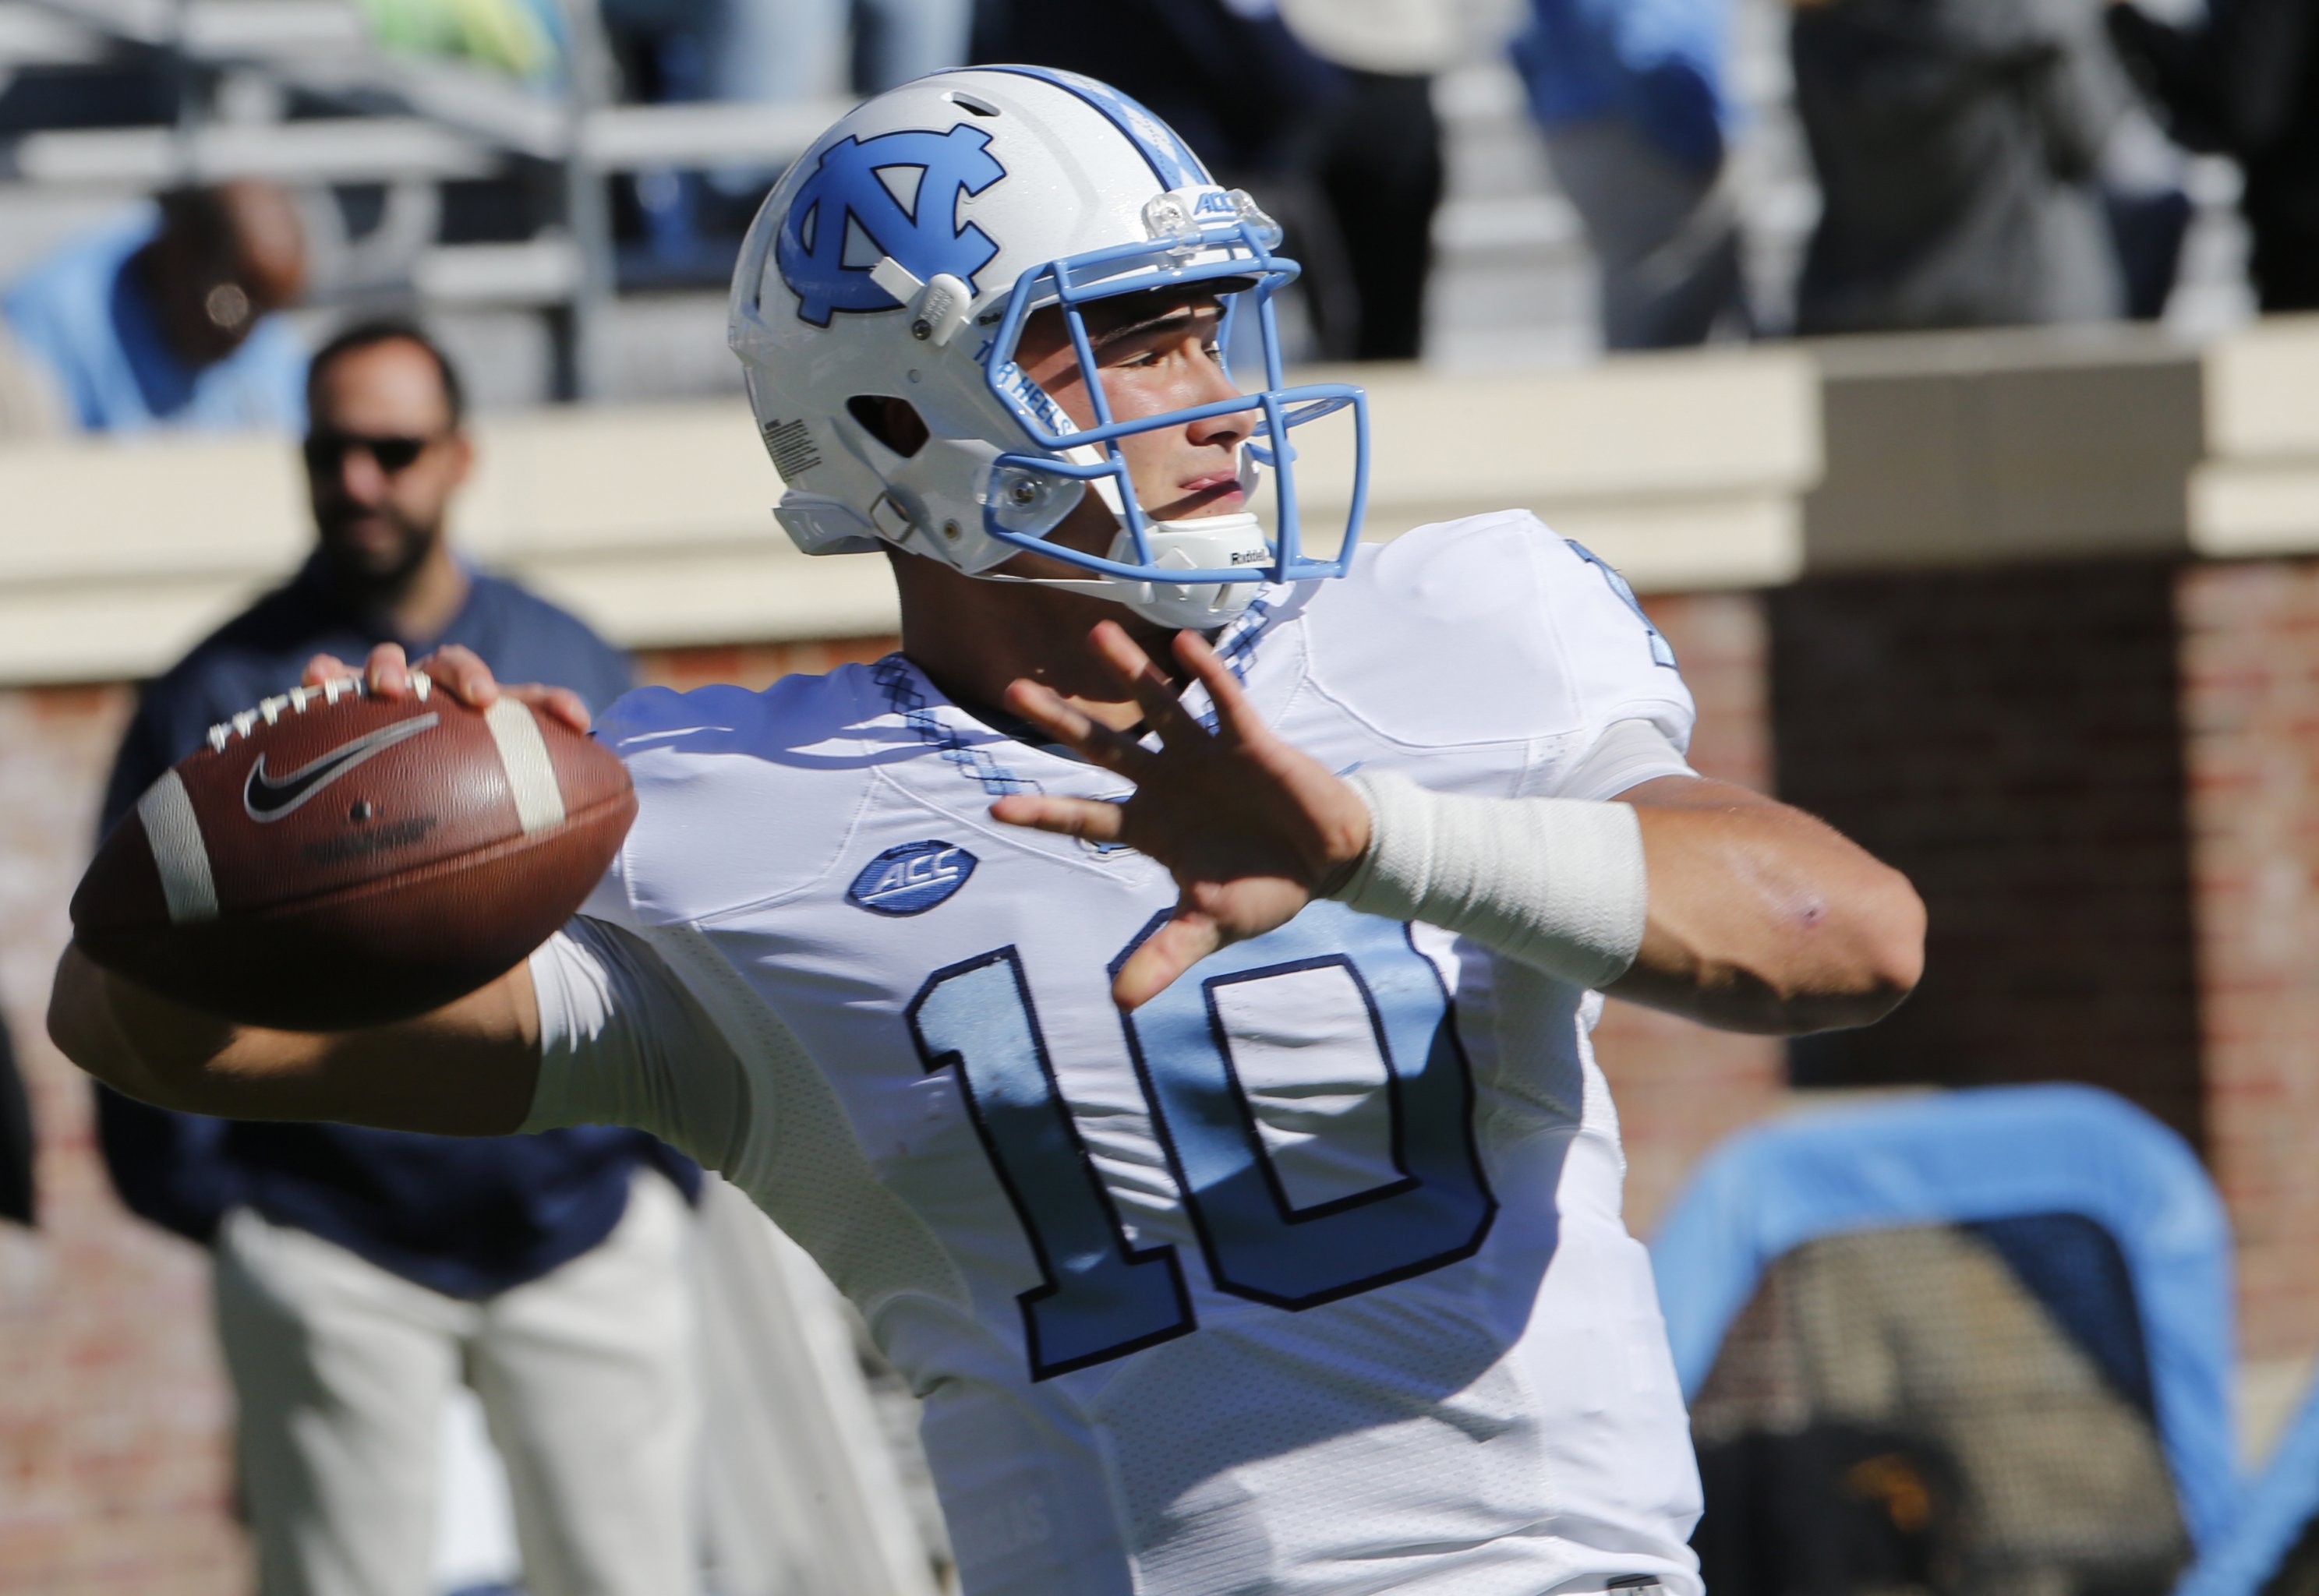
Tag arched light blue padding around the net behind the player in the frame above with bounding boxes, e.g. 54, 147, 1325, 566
1651, 1086, 2240, 1549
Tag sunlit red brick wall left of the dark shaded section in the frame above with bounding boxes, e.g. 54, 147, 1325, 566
0, 596, 1781, 1596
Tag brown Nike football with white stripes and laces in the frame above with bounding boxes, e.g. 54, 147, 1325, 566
72, 682, 635, 1030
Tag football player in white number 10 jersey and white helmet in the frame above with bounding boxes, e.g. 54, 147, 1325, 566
51, 67, 1922, 1596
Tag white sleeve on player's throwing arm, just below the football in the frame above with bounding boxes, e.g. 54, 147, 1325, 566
521, 916, 749, 1169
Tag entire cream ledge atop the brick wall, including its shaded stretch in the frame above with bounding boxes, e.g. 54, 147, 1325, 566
0, 318, 2319, 682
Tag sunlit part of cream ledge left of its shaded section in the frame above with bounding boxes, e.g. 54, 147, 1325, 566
0, 352, 1818, 682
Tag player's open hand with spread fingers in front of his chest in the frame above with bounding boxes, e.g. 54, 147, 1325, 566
990, 622, 1368, 1009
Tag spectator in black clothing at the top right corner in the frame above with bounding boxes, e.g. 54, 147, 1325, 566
2108, 0, 2319, 311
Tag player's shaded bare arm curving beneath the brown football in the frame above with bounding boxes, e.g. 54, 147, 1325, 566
48, 948, 538, 1135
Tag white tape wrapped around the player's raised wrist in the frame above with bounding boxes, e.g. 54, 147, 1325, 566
1336, 772, 1649, 988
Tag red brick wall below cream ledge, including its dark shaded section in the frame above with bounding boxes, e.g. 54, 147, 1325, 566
18, 563, 2319, 1568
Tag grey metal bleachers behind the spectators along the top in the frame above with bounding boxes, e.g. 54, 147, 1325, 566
0, 0, 2250, 406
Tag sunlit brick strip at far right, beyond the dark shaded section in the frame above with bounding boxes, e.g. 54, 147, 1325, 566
2178, 561, 2319, 1357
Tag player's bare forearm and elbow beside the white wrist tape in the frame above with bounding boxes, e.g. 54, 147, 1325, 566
1607, 782, 1925, 1035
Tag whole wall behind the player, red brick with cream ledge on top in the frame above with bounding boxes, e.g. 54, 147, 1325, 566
0, 323, 2319, 1596
